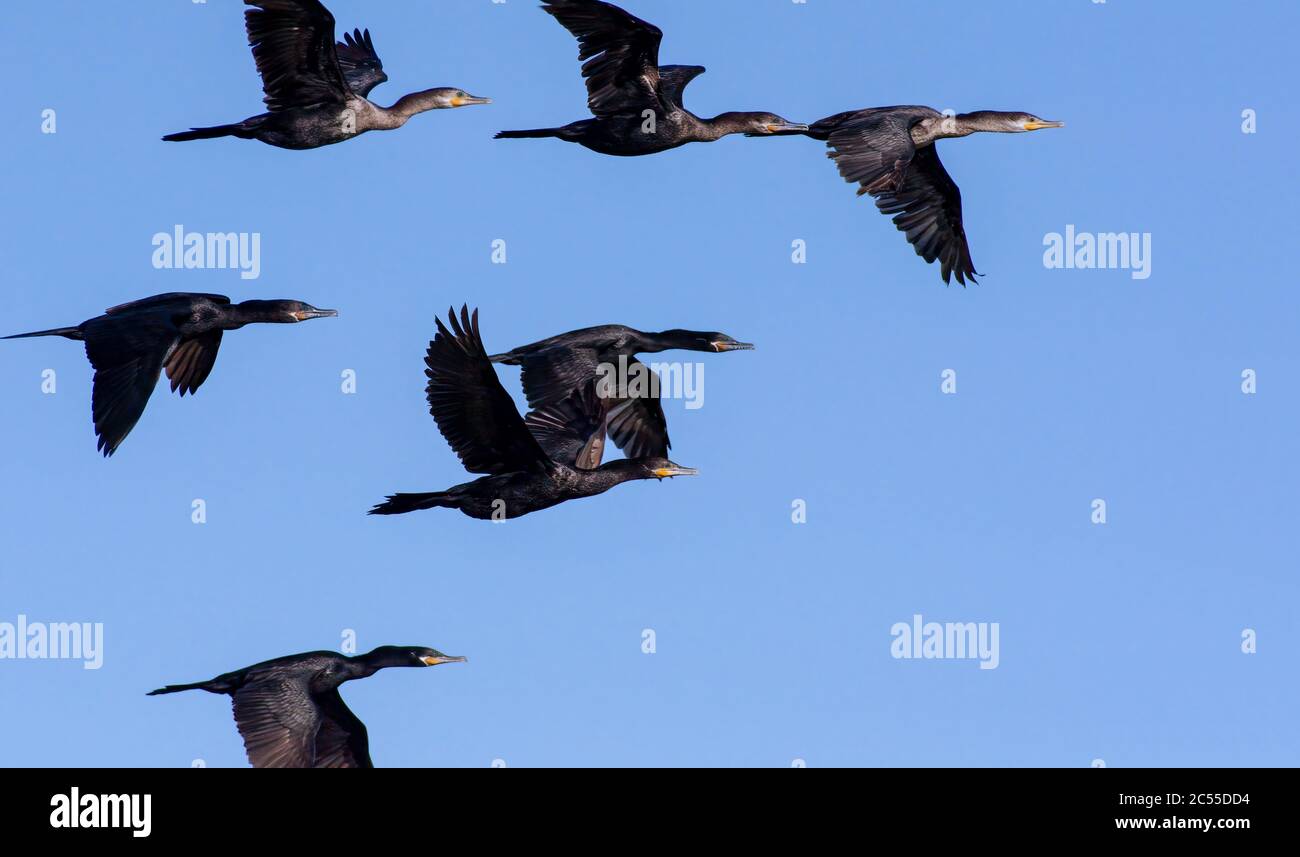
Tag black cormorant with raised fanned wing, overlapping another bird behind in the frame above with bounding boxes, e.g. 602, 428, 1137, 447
371, 307, 696, 520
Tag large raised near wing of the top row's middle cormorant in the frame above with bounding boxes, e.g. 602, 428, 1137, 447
542, 0, 664, 116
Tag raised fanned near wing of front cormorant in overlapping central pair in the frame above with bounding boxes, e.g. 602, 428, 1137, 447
424, 307, 551, 473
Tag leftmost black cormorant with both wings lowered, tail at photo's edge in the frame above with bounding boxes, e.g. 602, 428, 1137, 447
3, 291, 338, 456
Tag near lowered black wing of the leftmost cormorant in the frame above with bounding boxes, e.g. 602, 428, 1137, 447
82, 313, 181, 456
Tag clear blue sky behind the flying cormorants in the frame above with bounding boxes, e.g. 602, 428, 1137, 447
0, 0, 1300, 766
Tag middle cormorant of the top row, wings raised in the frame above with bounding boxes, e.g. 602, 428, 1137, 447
497, 0, 807, 156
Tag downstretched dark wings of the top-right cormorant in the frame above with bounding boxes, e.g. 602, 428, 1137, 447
813, 109, 978, 285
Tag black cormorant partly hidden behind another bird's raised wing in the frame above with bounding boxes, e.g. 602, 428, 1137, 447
490, 324, 754, 467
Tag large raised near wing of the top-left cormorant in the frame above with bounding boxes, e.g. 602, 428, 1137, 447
244, 0, 352, 113
